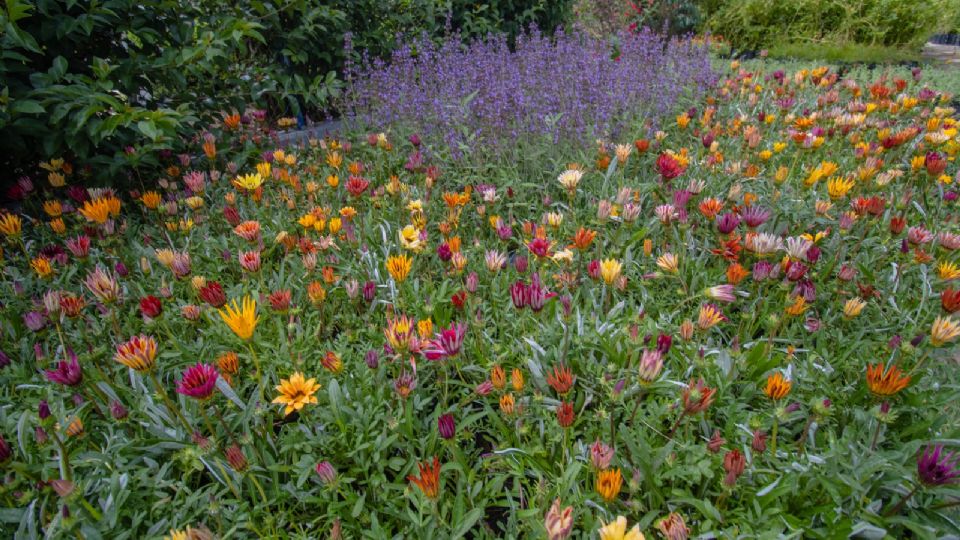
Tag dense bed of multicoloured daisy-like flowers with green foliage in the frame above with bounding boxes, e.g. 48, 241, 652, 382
0, 58, 960, 540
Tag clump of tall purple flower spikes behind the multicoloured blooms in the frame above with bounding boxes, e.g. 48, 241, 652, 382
344, 31, 713, 160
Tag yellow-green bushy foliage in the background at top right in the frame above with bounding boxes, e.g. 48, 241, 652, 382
708, 0, 960, 49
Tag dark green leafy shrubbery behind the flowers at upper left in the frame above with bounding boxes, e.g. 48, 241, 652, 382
0, 0, 569, 188
